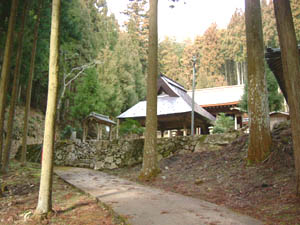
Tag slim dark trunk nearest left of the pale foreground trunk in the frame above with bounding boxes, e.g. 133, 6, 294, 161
21, 0, 43, 164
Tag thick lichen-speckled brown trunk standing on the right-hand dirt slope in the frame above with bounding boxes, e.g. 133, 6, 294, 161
245, 0, 271, 163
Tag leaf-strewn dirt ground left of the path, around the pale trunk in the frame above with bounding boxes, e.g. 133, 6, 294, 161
0, 161, 125, 225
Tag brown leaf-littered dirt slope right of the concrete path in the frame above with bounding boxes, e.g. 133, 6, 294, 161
110, 123, 300, 225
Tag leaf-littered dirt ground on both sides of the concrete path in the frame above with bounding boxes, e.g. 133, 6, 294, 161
0, 118, 300, 225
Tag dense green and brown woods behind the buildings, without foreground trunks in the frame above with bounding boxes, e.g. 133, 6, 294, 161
0, 0, 300, 132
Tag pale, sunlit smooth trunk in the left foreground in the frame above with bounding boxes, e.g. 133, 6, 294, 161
35, 0, 61, 216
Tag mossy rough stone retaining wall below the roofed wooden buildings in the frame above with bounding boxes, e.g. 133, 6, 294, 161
54, 133, 238, 170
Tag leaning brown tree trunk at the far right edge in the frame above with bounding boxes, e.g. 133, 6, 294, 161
274, 0, 300, 196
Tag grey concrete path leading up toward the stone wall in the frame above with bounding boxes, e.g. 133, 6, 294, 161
55, 167, 262, 225
